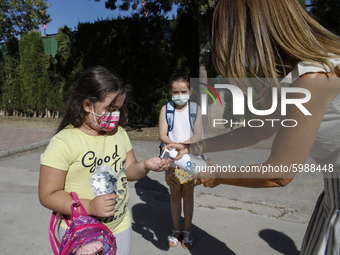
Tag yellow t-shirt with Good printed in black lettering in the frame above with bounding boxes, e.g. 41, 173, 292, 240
40, 125, 132, 234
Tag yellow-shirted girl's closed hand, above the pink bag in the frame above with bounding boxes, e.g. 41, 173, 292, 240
88, 194, 118, 217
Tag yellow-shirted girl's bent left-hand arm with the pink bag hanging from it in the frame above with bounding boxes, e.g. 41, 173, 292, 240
39, 165, 118, 217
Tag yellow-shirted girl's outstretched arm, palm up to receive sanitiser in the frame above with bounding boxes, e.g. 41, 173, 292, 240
126, 150, 171, 181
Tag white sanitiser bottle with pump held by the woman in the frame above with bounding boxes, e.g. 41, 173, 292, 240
161, 148, 207, 174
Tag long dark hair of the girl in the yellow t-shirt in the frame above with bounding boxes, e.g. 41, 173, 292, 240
56, 66, 129, 133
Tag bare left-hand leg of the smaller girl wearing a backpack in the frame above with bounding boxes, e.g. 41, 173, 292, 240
170, 185, 183, 231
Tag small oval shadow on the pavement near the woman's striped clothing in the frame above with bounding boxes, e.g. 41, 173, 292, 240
259, 229, 300, 255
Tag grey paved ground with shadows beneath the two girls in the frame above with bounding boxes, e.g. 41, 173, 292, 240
0, 128, 323, 255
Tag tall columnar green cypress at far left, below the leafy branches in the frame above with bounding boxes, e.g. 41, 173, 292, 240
19, 31, 47, 115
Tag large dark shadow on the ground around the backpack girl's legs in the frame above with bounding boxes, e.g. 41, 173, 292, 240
131, 176, 235, 255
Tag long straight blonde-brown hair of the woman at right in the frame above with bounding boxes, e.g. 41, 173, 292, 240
213, 0, 340, 97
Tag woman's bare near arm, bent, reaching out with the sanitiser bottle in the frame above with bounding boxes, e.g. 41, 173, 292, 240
195, 73, 340, 187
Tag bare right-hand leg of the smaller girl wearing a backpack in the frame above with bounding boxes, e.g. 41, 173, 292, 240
182, 184, 194, 231
